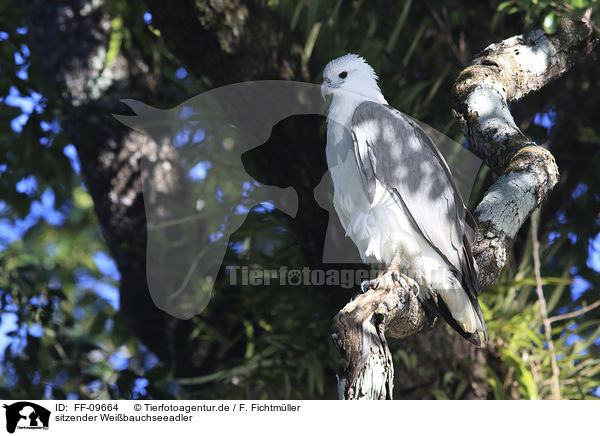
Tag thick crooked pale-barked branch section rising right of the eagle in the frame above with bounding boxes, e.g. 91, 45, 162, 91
454, 11, 597, 288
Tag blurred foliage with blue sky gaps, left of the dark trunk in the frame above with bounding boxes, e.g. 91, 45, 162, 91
0, 3, 183, 399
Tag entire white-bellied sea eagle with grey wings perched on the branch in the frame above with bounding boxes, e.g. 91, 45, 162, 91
321, 54, 487, 346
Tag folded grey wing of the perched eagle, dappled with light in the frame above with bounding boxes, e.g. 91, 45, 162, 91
351, 102, 480, 298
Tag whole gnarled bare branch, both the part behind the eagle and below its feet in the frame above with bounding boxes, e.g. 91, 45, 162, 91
333, 11, 597, 399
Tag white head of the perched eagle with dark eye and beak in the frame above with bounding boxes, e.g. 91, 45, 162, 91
321, 53, 385, 103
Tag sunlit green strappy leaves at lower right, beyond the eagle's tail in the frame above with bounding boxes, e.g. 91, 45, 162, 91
482, 204, 600, 399
